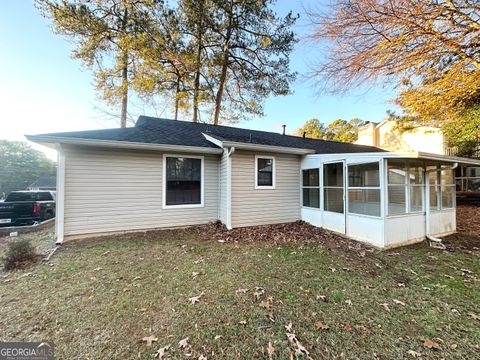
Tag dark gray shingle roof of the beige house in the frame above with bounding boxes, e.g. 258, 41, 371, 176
31, 116, 384, 154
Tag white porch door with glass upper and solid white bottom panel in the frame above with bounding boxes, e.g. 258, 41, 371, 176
322, 160, 347, 234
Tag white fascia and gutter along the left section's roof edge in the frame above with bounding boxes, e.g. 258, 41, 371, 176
25, 135, 223, 154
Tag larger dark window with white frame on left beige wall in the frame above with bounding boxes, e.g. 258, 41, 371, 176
163, 156, 203, 206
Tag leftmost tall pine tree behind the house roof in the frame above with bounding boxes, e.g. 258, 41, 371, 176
36, 0, 162, 127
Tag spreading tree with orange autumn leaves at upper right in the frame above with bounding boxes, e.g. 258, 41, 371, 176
309, 0, 480, 122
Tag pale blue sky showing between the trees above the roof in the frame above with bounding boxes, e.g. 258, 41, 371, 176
0, 0, 395, 158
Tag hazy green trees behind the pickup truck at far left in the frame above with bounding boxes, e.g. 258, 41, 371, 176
0, 140, 56, 194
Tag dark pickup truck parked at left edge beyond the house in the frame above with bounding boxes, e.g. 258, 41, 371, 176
0, 191, 55, 226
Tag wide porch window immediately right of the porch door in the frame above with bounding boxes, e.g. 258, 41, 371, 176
348, 162, 380, 216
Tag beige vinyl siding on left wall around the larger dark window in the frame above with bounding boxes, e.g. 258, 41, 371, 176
65, 147, 219, 236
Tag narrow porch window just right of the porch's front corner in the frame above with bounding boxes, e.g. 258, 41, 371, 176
387, 160, 408, 215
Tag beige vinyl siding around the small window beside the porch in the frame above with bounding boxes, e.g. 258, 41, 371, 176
232, 151, 300, 227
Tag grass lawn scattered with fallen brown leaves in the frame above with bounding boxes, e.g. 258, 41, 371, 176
0, 224, 480, 359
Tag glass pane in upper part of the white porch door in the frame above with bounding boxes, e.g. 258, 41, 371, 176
323, 162, 344, 214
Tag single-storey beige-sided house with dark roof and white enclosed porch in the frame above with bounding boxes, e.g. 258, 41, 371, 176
27, 116, 480, 248
